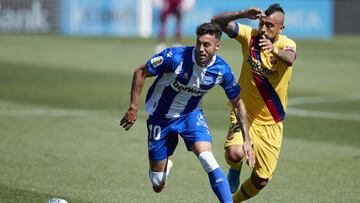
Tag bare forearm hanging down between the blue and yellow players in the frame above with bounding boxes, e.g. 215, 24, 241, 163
230, 95, 255, 168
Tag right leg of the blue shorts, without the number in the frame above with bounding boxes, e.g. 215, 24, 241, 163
176, 111, 212, 151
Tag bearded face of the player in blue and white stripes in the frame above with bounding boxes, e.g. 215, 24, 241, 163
195, 34, 220, 67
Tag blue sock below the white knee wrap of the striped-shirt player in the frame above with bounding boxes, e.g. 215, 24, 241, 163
208, 167, 233, 203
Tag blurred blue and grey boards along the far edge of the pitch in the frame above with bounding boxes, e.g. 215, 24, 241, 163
0, 0, 360, 38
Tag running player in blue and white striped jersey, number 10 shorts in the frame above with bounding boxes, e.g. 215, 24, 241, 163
120, 23, 255, 202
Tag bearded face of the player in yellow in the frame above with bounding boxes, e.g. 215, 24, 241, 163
259, 12, 284, 41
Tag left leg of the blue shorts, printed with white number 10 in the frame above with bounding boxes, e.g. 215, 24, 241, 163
147, 118, 178, 161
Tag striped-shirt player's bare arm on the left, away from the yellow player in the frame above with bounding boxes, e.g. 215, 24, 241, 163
120, 64, 151, 130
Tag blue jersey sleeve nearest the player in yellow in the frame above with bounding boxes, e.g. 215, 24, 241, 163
220, 67, 240, 100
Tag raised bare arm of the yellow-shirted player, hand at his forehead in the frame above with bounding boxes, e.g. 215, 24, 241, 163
211, 8, 266, 36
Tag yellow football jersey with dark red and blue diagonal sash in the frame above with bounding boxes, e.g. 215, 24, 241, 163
235, 24, 296, 125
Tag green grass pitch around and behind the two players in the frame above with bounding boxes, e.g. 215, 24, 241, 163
0, 35, 360, 203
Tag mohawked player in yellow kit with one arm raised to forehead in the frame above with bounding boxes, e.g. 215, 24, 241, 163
212, 4, 296, 202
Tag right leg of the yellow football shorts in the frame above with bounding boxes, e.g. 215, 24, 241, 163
249, 123, 283, 179
